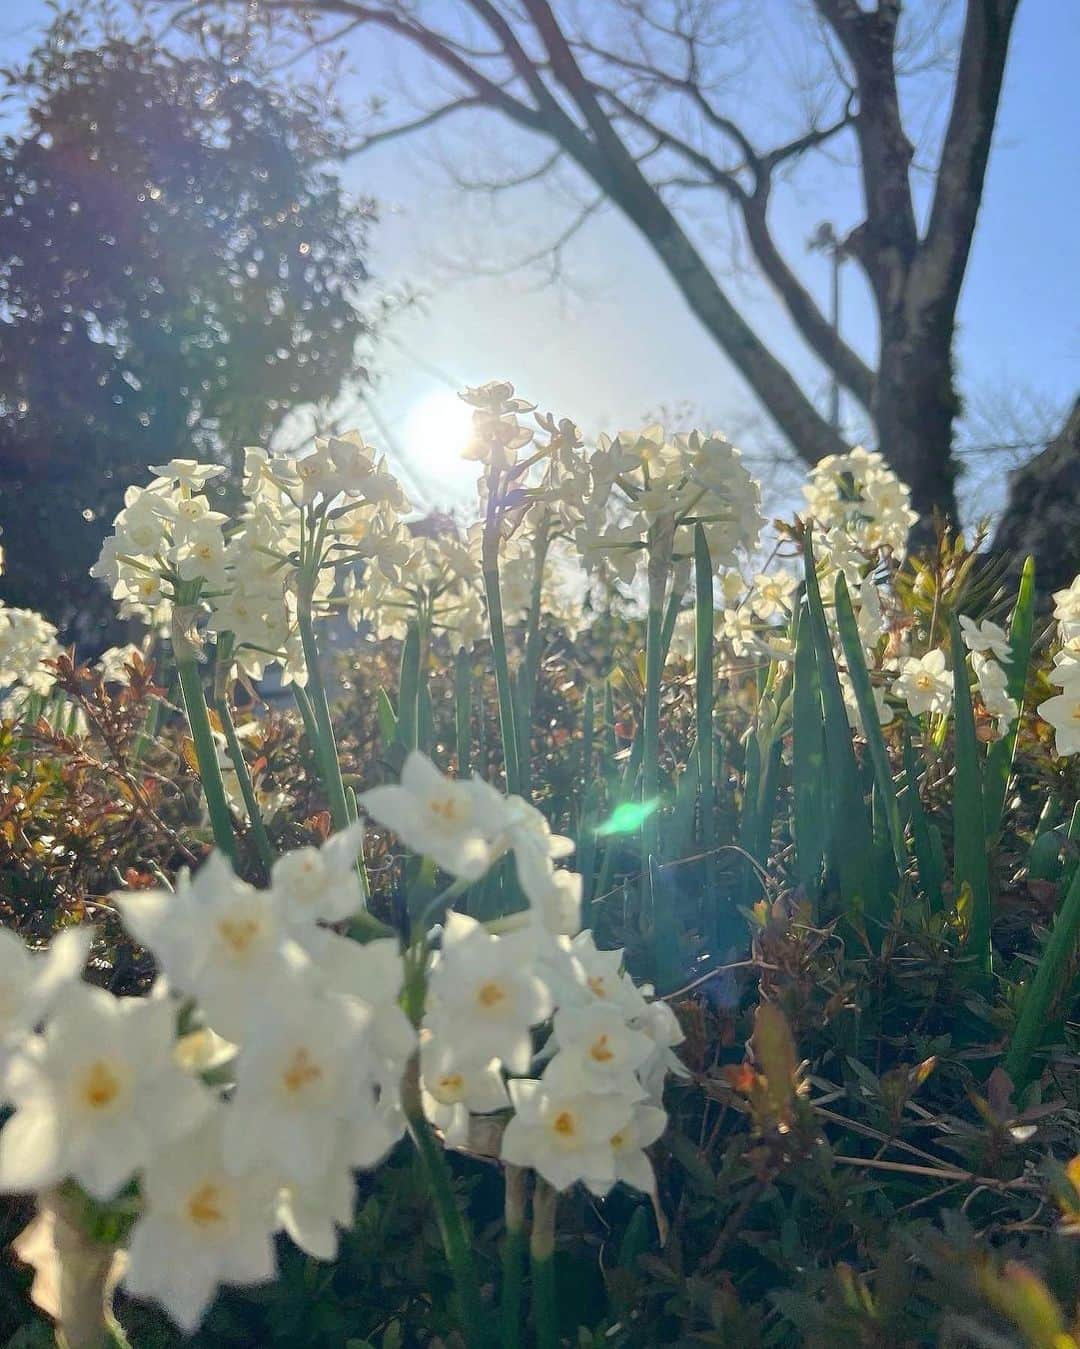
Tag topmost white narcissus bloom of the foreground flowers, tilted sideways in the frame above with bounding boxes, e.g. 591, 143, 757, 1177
359, 750, 503, 881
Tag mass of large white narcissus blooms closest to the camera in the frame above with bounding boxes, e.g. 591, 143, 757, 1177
0, 754, 681, 1331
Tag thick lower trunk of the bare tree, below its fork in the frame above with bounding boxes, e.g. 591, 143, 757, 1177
874, 325, 960, 536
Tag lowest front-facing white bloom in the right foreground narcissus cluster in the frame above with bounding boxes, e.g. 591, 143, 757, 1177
500, 1074, 636, 1190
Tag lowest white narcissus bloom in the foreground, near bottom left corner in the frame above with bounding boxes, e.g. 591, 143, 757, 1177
124, 1106, 279, 1334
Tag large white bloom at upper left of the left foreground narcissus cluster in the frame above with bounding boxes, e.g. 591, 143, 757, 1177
112, 851, 306, 1041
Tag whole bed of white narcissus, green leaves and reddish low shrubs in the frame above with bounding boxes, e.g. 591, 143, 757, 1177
0, 383, 1080, 1349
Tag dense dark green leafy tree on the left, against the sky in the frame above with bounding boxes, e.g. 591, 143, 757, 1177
0, 7, 369, 645
